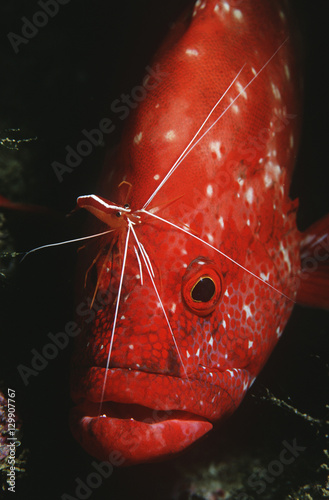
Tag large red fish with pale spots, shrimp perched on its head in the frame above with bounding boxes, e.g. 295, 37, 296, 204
71, 0, 329, 465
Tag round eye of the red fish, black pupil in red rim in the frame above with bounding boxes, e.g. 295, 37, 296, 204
182, 257, 225, 316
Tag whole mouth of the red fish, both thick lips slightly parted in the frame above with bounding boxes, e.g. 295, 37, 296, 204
70, 367, 249, 466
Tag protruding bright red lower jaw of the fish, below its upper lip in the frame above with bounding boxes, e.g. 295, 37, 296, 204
70, 401, 212, 466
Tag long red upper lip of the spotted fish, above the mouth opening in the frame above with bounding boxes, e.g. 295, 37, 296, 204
72, 366, 253, 422
